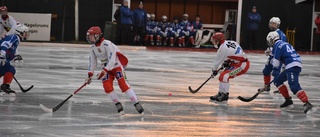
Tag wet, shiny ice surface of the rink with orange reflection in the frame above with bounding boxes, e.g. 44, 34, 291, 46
0, 43, 320, 137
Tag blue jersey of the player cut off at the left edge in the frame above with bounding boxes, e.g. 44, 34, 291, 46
0, 35, 20, 62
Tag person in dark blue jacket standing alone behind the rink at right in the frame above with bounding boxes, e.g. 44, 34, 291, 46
247, 6, 261, 49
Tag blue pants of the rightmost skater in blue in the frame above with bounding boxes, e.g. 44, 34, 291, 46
273, 67, 302, 94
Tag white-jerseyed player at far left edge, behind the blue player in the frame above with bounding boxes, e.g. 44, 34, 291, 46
0, 6, 23, 61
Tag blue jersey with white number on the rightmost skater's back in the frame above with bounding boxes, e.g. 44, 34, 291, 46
272, 40, 302, 69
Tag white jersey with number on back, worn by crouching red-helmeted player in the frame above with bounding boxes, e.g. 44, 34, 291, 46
212, 40, 247, 70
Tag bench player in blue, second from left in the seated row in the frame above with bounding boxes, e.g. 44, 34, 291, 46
157, 15, 170, 46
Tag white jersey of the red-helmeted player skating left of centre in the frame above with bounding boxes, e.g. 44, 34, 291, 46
88, 39, 128, 74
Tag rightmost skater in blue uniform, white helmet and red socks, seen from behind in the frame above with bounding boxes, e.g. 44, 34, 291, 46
266, 31, 317, 114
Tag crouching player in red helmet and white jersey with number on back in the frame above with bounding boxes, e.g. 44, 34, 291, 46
210, 32, 250, 102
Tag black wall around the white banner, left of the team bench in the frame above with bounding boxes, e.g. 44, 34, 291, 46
0, 0, 112, 42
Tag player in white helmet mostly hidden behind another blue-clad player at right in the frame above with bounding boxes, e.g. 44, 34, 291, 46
258, 17, 287, 91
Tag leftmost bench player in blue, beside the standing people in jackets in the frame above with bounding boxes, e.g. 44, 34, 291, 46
145, 14, 157, 46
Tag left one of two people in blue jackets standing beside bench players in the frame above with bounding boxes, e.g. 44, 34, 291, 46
120, 0, 132, 45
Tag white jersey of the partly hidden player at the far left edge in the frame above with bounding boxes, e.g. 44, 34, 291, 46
0, 15, 17, 37
